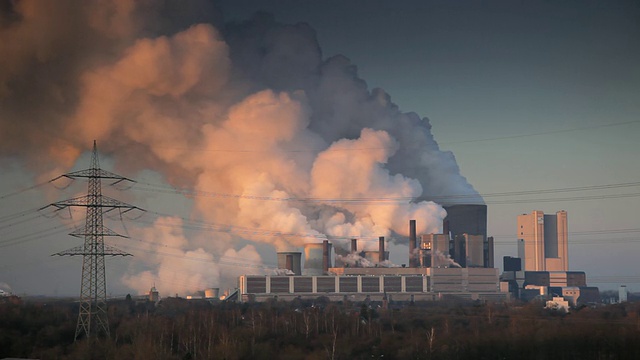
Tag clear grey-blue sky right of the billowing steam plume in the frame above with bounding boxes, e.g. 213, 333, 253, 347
223, 1, 640, 289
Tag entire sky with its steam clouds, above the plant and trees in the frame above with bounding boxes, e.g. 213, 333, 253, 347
0, 0, 640, 295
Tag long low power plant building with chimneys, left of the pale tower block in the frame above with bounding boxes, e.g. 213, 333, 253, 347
238, 217, 508, 301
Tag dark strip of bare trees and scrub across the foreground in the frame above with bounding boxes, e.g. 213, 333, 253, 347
0, 298, 640, 360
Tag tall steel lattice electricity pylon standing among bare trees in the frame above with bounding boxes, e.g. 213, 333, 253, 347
48, 140, 138, 340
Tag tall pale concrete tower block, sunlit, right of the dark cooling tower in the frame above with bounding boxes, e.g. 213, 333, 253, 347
517, 210, 569, 271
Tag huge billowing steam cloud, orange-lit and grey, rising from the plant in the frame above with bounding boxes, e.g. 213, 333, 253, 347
0, 0, 476, 292
